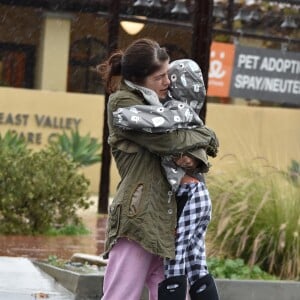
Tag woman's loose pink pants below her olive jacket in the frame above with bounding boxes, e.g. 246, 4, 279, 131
102, 238, 164, 300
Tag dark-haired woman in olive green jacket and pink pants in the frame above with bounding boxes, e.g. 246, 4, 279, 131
100, 39, 216, 300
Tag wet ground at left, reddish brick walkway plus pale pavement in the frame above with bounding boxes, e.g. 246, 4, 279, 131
0, 206, 107, 300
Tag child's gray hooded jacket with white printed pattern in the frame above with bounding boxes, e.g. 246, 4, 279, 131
113, 59, 219, 191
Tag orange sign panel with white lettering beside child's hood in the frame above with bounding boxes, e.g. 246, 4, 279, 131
207, 42, 235, 97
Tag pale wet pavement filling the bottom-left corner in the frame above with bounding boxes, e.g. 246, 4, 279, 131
0, 256, 75, 300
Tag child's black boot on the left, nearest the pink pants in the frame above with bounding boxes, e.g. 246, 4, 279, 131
158, 275, 187, 300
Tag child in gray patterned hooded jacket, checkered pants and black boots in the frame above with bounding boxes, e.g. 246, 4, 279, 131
114, 59, 219, 300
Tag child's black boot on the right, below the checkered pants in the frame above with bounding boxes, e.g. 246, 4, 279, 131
190, 274, 219, 300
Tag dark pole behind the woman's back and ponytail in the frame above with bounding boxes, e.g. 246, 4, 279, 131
98, 0, 121, 214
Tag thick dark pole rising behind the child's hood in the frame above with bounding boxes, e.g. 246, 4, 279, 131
191, 0, 214, 123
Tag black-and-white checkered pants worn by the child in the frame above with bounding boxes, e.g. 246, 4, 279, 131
165, 182, 211, 285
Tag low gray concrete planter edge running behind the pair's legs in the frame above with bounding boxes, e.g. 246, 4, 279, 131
34, 262, 300, 300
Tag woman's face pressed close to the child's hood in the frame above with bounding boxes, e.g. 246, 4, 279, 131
143, 60, 170, 99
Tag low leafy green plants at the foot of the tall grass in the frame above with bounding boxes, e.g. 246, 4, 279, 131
207, 257, 277, 280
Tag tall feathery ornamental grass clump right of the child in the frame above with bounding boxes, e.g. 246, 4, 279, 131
207, 161, 300, 279
